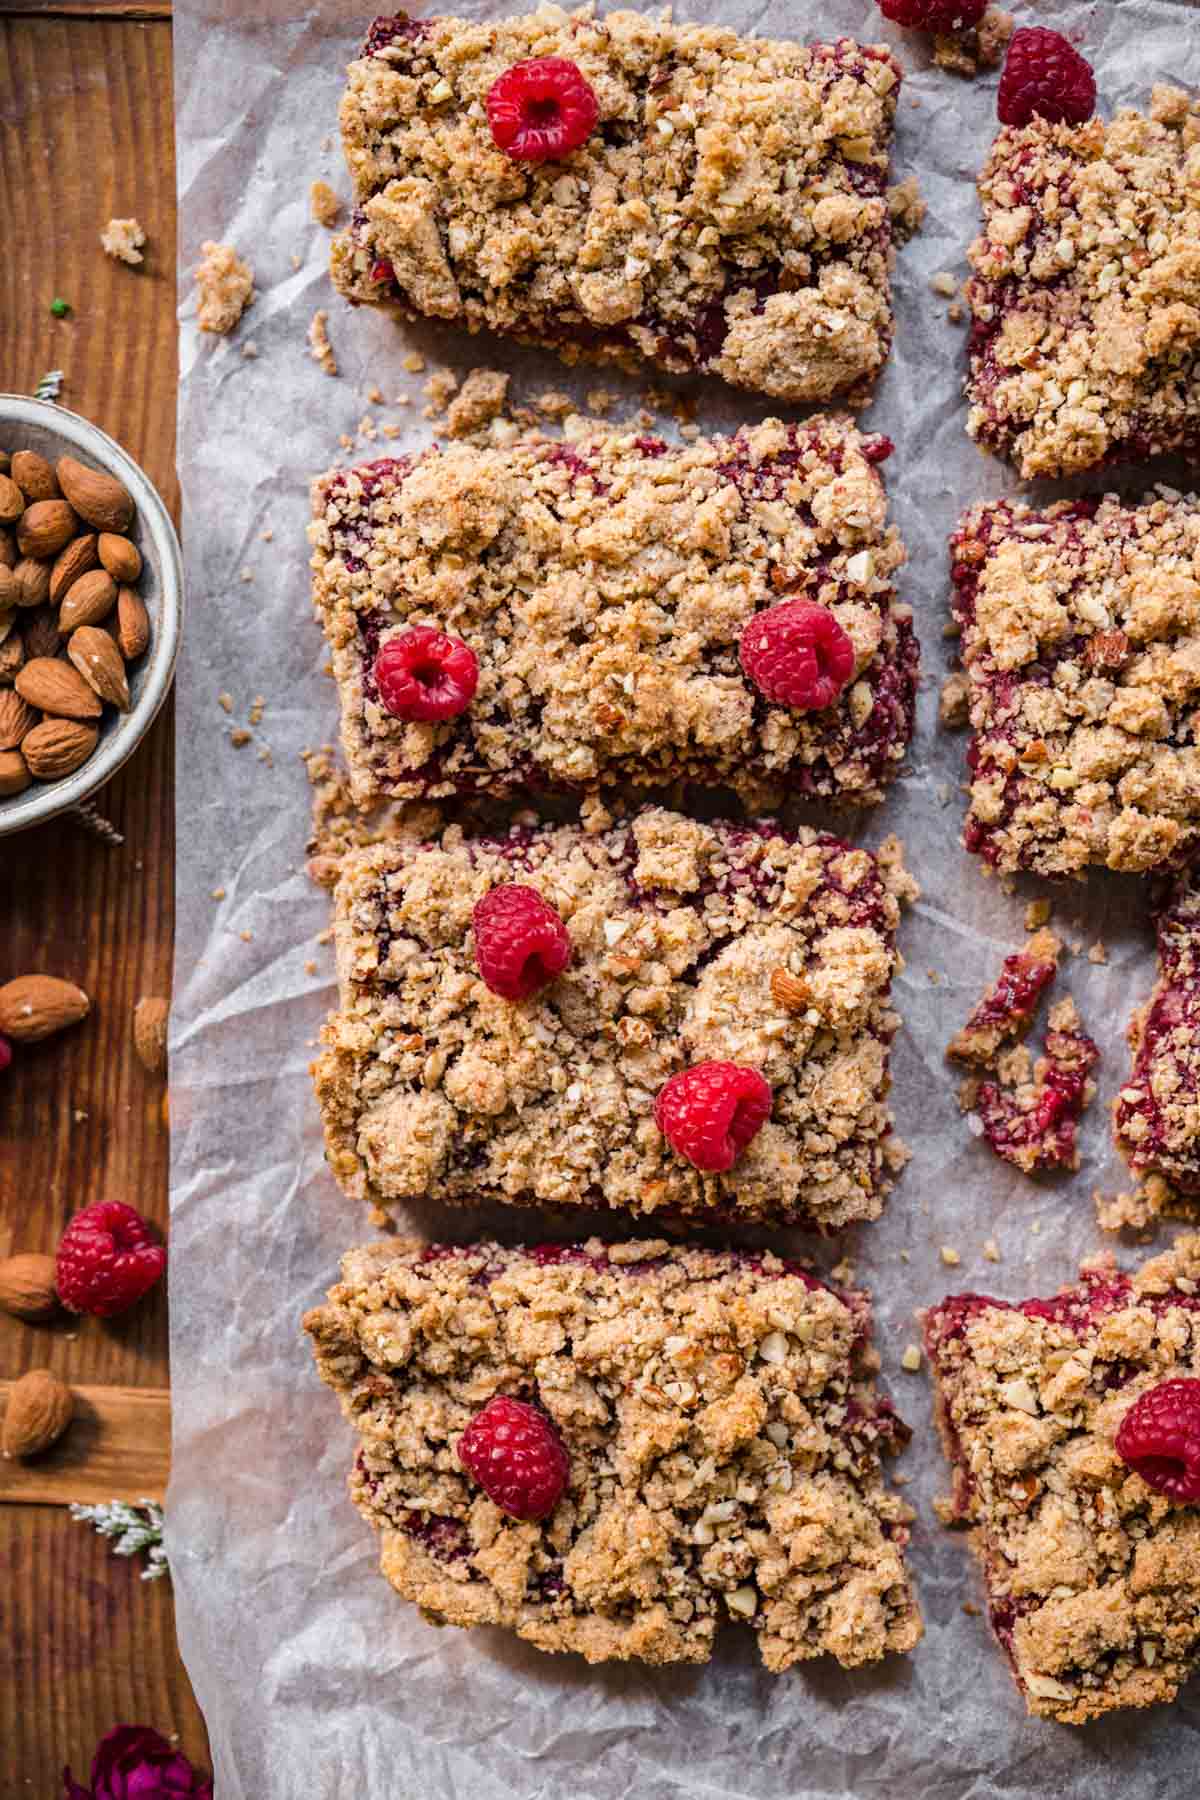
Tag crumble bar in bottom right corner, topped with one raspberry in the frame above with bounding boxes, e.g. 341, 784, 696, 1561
925, 1237, 1200, 1724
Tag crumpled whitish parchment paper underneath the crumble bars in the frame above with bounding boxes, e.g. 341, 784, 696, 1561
173, 0, 1200, 1800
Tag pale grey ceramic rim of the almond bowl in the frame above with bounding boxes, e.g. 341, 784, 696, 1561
0, 392, 184, 837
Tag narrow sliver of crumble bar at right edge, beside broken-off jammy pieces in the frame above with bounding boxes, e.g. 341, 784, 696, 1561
1112, 875, 1200, 1211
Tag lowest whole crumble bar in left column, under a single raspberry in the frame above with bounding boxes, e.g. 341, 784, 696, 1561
304, 1240, 921, 1670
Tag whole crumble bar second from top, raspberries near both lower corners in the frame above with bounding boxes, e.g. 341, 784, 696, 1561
309, 418, 918, 805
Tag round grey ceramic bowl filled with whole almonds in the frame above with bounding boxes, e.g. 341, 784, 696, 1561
0, 394, 184, 837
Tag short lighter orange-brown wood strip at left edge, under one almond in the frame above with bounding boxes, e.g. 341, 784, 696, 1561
0, 1381, 171, 1507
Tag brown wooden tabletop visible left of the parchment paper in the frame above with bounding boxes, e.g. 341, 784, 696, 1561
0, 0, 209, 1800
